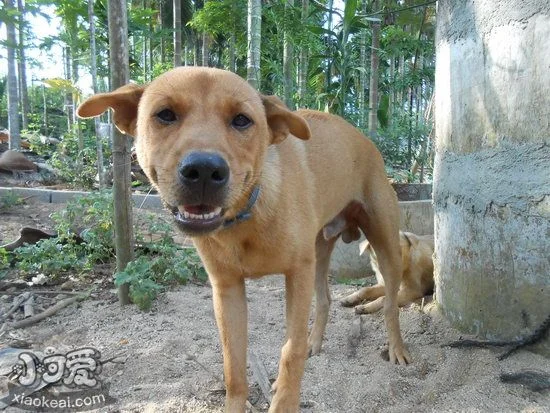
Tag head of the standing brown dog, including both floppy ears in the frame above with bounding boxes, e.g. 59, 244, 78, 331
77, 67, 310, 235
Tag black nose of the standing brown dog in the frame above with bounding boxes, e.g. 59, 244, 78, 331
178, 152, 229, 192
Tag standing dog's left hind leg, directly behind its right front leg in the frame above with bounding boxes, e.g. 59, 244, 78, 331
308, 232, 338, 356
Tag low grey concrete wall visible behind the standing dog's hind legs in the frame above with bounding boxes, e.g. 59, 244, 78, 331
330, 199, 434, 278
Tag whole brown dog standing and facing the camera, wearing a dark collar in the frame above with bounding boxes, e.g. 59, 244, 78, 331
78, 68, 409, 412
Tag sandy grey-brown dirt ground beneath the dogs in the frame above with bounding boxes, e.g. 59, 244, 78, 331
0, 199, 550, 413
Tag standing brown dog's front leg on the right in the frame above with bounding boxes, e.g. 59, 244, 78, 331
269, 260, 315, 412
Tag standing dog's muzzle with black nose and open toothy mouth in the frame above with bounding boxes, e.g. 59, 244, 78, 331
175, 152, 230, 234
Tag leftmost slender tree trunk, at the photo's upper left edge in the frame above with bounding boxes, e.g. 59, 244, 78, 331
4, 0, 21, 150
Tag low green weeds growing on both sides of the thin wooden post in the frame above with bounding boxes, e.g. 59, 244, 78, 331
12, 191, 206, 310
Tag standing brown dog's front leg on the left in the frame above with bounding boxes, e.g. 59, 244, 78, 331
210, 276, 248, 413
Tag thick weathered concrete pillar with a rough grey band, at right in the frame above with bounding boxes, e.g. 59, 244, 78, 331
434, 0, 550, 351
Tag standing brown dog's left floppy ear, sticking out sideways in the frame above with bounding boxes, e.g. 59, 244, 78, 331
76, 83, 145, 136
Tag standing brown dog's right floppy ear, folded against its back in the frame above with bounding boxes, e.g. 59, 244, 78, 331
262, 95, 311, 143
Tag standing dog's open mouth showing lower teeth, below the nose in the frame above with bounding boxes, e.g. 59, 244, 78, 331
172, 204, 223, 234
